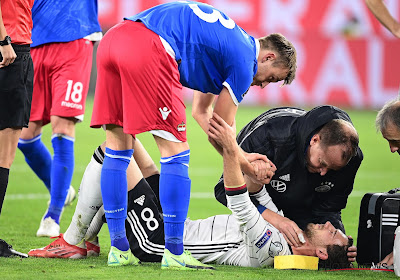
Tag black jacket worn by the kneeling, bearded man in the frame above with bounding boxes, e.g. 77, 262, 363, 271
215, 106, 363, 231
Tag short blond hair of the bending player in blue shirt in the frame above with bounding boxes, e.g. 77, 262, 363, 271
258, 33, 297, 85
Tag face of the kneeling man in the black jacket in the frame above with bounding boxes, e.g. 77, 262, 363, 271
306, 134, 347, 176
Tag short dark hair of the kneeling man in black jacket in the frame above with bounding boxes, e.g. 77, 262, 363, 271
317, 119, 359, 162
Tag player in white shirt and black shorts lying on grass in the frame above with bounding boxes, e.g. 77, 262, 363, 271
29, 114, 352, 269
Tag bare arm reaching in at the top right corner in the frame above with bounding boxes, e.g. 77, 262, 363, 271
365, 0, 400, 38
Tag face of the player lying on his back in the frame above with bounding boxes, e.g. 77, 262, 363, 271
305, 222, 349, 247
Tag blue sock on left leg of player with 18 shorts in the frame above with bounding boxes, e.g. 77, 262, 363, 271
18, 134, 52, 192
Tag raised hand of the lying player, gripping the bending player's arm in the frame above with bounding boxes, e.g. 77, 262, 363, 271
208, 113, 237, 150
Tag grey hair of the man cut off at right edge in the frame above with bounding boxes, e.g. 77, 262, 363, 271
375, 98, 400, 132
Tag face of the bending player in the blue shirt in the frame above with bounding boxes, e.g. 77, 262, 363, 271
251, 54, 289, 88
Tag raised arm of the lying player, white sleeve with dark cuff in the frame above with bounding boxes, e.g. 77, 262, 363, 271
208, 114, 288, 266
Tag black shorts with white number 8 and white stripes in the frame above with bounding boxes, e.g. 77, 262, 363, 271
125, 179, 165, 262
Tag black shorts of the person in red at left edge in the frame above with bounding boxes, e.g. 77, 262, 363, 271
0, 45, 33, 130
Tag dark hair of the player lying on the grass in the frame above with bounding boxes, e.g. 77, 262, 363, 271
318, 238, 353, 269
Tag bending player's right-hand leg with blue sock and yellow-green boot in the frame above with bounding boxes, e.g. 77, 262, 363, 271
154, 136, 213, 270
